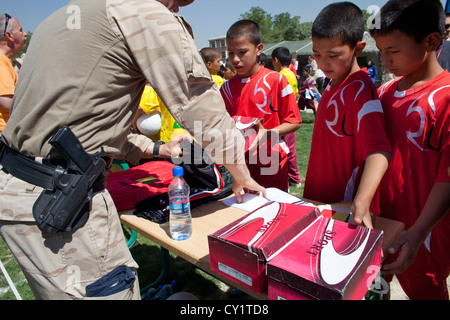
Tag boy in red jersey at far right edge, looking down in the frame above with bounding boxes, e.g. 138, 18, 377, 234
371, 0, 450, 300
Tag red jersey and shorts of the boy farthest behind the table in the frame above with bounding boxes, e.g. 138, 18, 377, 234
220, 68, 302, 191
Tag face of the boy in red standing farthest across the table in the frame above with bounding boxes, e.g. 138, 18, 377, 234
227, 36, 263, 78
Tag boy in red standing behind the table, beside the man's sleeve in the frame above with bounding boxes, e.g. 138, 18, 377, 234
220, 20, 301, 191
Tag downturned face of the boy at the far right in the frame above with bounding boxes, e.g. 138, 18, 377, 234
375, 30, 427, 76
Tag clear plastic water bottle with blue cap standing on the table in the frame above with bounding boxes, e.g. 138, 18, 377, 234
167, 167, 192, 240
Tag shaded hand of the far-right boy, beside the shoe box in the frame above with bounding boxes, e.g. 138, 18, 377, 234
383, 230, 421, 274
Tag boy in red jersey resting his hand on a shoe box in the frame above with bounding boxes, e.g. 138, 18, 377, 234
304, 2, 391, 227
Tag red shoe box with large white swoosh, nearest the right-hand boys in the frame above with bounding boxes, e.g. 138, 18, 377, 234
267, 215, 383, 300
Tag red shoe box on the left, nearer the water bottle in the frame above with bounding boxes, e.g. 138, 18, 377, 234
208, 202, 321, 293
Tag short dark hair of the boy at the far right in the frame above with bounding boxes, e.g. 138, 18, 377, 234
370, 0, 445, 42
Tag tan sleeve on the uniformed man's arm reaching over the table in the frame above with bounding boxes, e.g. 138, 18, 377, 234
107, 0, 244, 163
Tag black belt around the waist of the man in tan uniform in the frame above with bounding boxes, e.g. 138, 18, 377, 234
0, 140, 106, 192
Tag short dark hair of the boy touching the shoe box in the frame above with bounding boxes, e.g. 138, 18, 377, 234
311, 2, 364, 49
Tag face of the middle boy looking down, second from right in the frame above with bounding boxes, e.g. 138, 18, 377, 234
312, 38, 365, 84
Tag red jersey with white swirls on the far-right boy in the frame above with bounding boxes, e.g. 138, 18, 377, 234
378, 71, 450, 291
